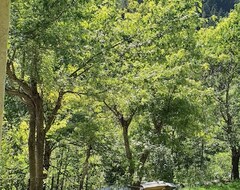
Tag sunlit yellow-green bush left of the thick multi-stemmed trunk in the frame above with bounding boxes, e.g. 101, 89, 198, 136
0, 121, 28, 189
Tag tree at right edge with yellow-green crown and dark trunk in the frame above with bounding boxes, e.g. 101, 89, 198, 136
200, 5, 240, 179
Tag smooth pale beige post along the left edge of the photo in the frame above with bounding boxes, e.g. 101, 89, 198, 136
0, 0, 10, 148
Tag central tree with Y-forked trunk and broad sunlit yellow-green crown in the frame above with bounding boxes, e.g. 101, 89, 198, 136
89, 1, 203, 184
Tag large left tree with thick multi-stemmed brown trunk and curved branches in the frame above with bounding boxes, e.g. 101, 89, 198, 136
6, 1, 85, 190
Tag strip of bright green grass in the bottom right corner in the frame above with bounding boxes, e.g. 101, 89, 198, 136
182, 181, 240, 190
